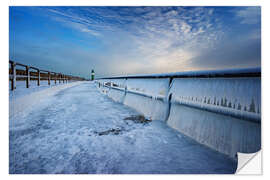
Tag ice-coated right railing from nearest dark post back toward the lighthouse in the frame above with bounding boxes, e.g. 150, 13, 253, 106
98, 78, 169, 121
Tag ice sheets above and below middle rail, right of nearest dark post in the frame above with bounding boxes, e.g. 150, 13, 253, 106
167, 78, 261, 157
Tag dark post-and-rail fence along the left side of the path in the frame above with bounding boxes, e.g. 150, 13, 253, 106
9, 61, 84, 91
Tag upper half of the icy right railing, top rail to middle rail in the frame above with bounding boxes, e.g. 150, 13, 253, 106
96, 68, 261, 121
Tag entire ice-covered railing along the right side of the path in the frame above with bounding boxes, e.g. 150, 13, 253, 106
95, 68, 261, 157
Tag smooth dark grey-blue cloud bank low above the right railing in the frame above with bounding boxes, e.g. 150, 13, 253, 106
189, 35, 261, 69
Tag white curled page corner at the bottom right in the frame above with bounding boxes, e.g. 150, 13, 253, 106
235, 150, 262, 175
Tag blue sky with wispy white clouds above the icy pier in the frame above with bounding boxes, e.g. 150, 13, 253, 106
9, 6, 261, 78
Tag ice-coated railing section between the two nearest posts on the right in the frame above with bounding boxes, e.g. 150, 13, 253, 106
124, 78, 169, 121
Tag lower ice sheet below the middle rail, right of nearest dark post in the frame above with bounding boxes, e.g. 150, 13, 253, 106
167, 104, 261, 158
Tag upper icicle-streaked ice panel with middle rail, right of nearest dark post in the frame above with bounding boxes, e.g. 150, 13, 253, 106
169, 78, 261, 121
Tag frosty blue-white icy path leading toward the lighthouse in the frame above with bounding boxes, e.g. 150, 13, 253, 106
9, 82, 236, 174
